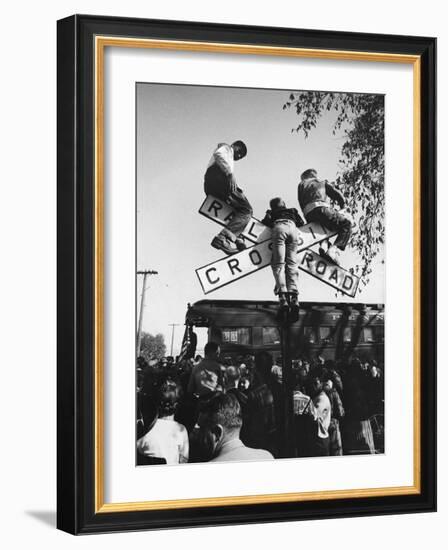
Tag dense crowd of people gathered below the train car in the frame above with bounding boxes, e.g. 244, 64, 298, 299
137, 348, 384, 464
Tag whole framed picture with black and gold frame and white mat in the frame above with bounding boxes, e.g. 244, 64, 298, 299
57, 15, 436, 534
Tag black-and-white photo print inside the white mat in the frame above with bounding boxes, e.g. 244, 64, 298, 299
135, 82, 388, 466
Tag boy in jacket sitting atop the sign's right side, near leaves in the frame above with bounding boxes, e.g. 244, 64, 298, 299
297, 168, 352, 265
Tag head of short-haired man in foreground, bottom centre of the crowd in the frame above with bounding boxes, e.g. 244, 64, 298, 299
198, 393, 243, 461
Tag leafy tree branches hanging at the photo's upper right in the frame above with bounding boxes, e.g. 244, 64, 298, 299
283, 92, 385, 285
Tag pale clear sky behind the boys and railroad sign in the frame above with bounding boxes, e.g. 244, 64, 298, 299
136, 83, 384, 354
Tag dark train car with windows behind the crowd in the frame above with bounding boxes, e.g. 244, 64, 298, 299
186, 300, 384, 365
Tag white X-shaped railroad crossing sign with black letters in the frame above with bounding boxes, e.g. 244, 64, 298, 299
196, 196, 360, 297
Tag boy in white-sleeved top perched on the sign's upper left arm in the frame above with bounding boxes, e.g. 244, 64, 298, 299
204, 140, 252, 255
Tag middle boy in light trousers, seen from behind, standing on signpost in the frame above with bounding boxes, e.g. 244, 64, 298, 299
262, 197, 304, 306
